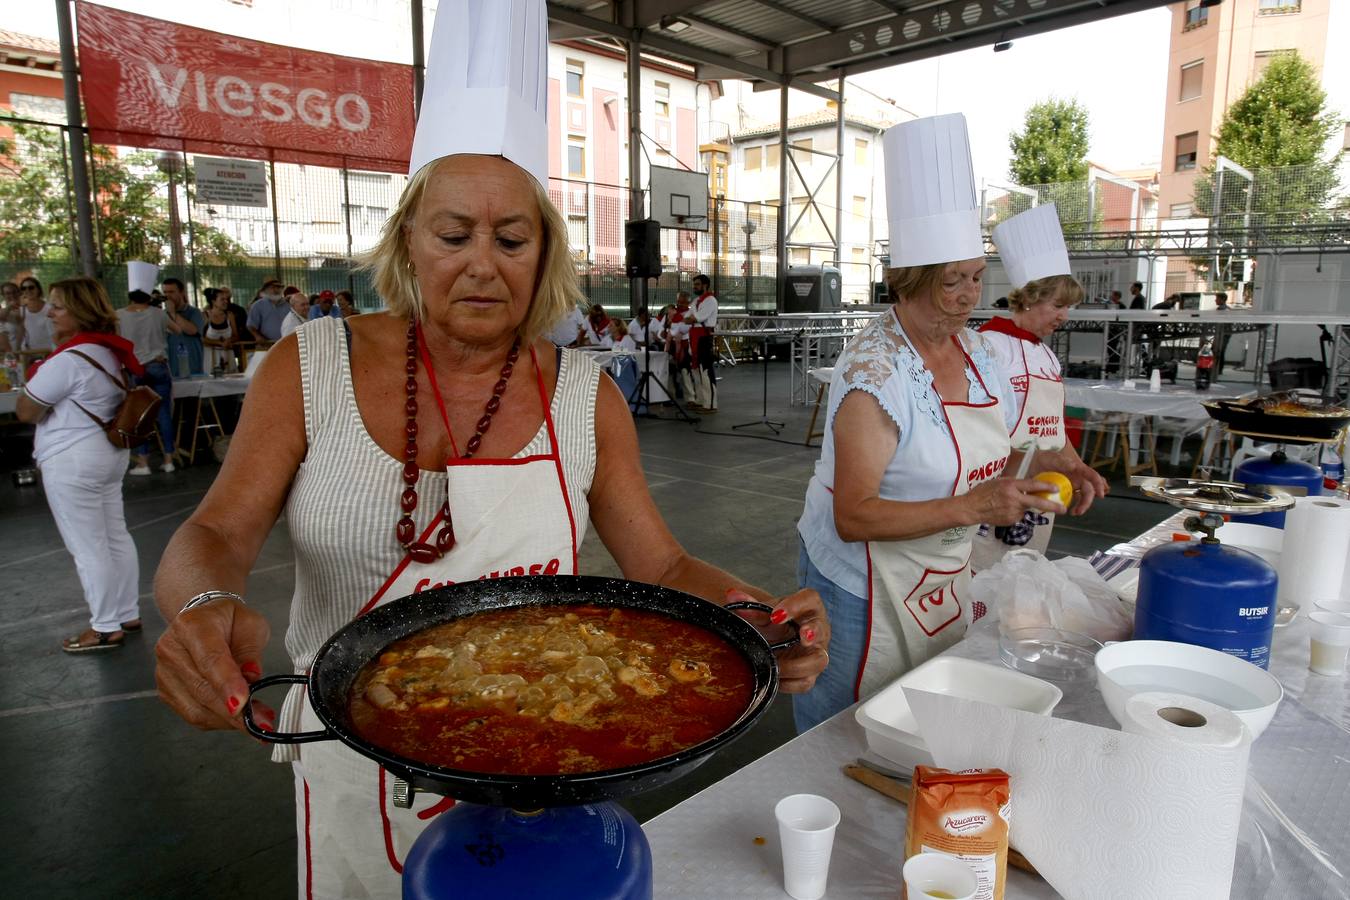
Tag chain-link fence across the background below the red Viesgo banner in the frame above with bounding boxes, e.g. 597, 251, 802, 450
0, 119, 778, 310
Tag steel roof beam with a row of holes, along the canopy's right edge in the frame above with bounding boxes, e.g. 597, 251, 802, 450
775, 0, 1168, 78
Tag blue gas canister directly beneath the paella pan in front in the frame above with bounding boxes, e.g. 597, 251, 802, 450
402, 803, 652, 900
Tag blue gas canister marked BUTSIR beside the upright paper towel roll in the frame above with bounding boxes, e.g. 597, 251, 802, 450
1134, 529, 1277, 668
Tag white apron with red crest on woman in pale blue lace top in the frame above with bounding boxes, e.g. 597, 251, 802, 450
855, 339, 1010, 699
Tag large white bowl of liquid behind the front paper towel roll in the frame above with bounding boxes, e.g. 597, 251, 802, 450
1096, 641, 1284, 739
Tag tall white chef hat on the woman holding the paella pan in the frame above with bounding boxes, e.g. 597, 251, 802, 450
408, 0, 548, 186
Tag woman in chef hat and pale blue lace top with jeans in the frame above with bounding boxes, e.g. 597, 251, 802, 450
794, 115, 1064, 730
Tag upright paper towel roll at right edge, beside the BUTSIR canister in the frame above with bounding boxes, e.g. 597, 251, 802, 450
1274, 497, 1350, 607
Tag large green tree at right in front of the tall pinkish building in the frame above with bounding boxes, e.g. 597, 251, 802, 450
1192, 51, 1345, 237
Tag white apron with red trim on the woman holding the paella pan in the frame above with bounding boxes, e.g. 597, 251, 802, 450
297, 351, 576, 899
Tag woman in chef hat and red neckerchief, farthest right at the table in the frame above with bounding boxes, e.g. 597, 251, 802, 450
972, 204, 1107, 571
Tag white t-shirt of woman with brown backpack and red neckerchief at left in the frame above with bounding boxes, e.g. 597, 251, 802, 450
23, 344, 126, 467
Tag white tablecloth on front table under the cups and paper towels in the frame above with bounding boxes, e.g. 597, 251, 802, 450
644, 524, 1350, 900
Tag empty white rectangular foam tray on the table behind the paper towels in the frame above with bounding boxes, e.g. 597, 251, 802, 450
853, 656, 1064, 769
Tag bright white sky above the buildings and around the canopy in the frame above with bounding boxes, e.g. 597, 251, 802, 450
5, 0, 1350, 184
